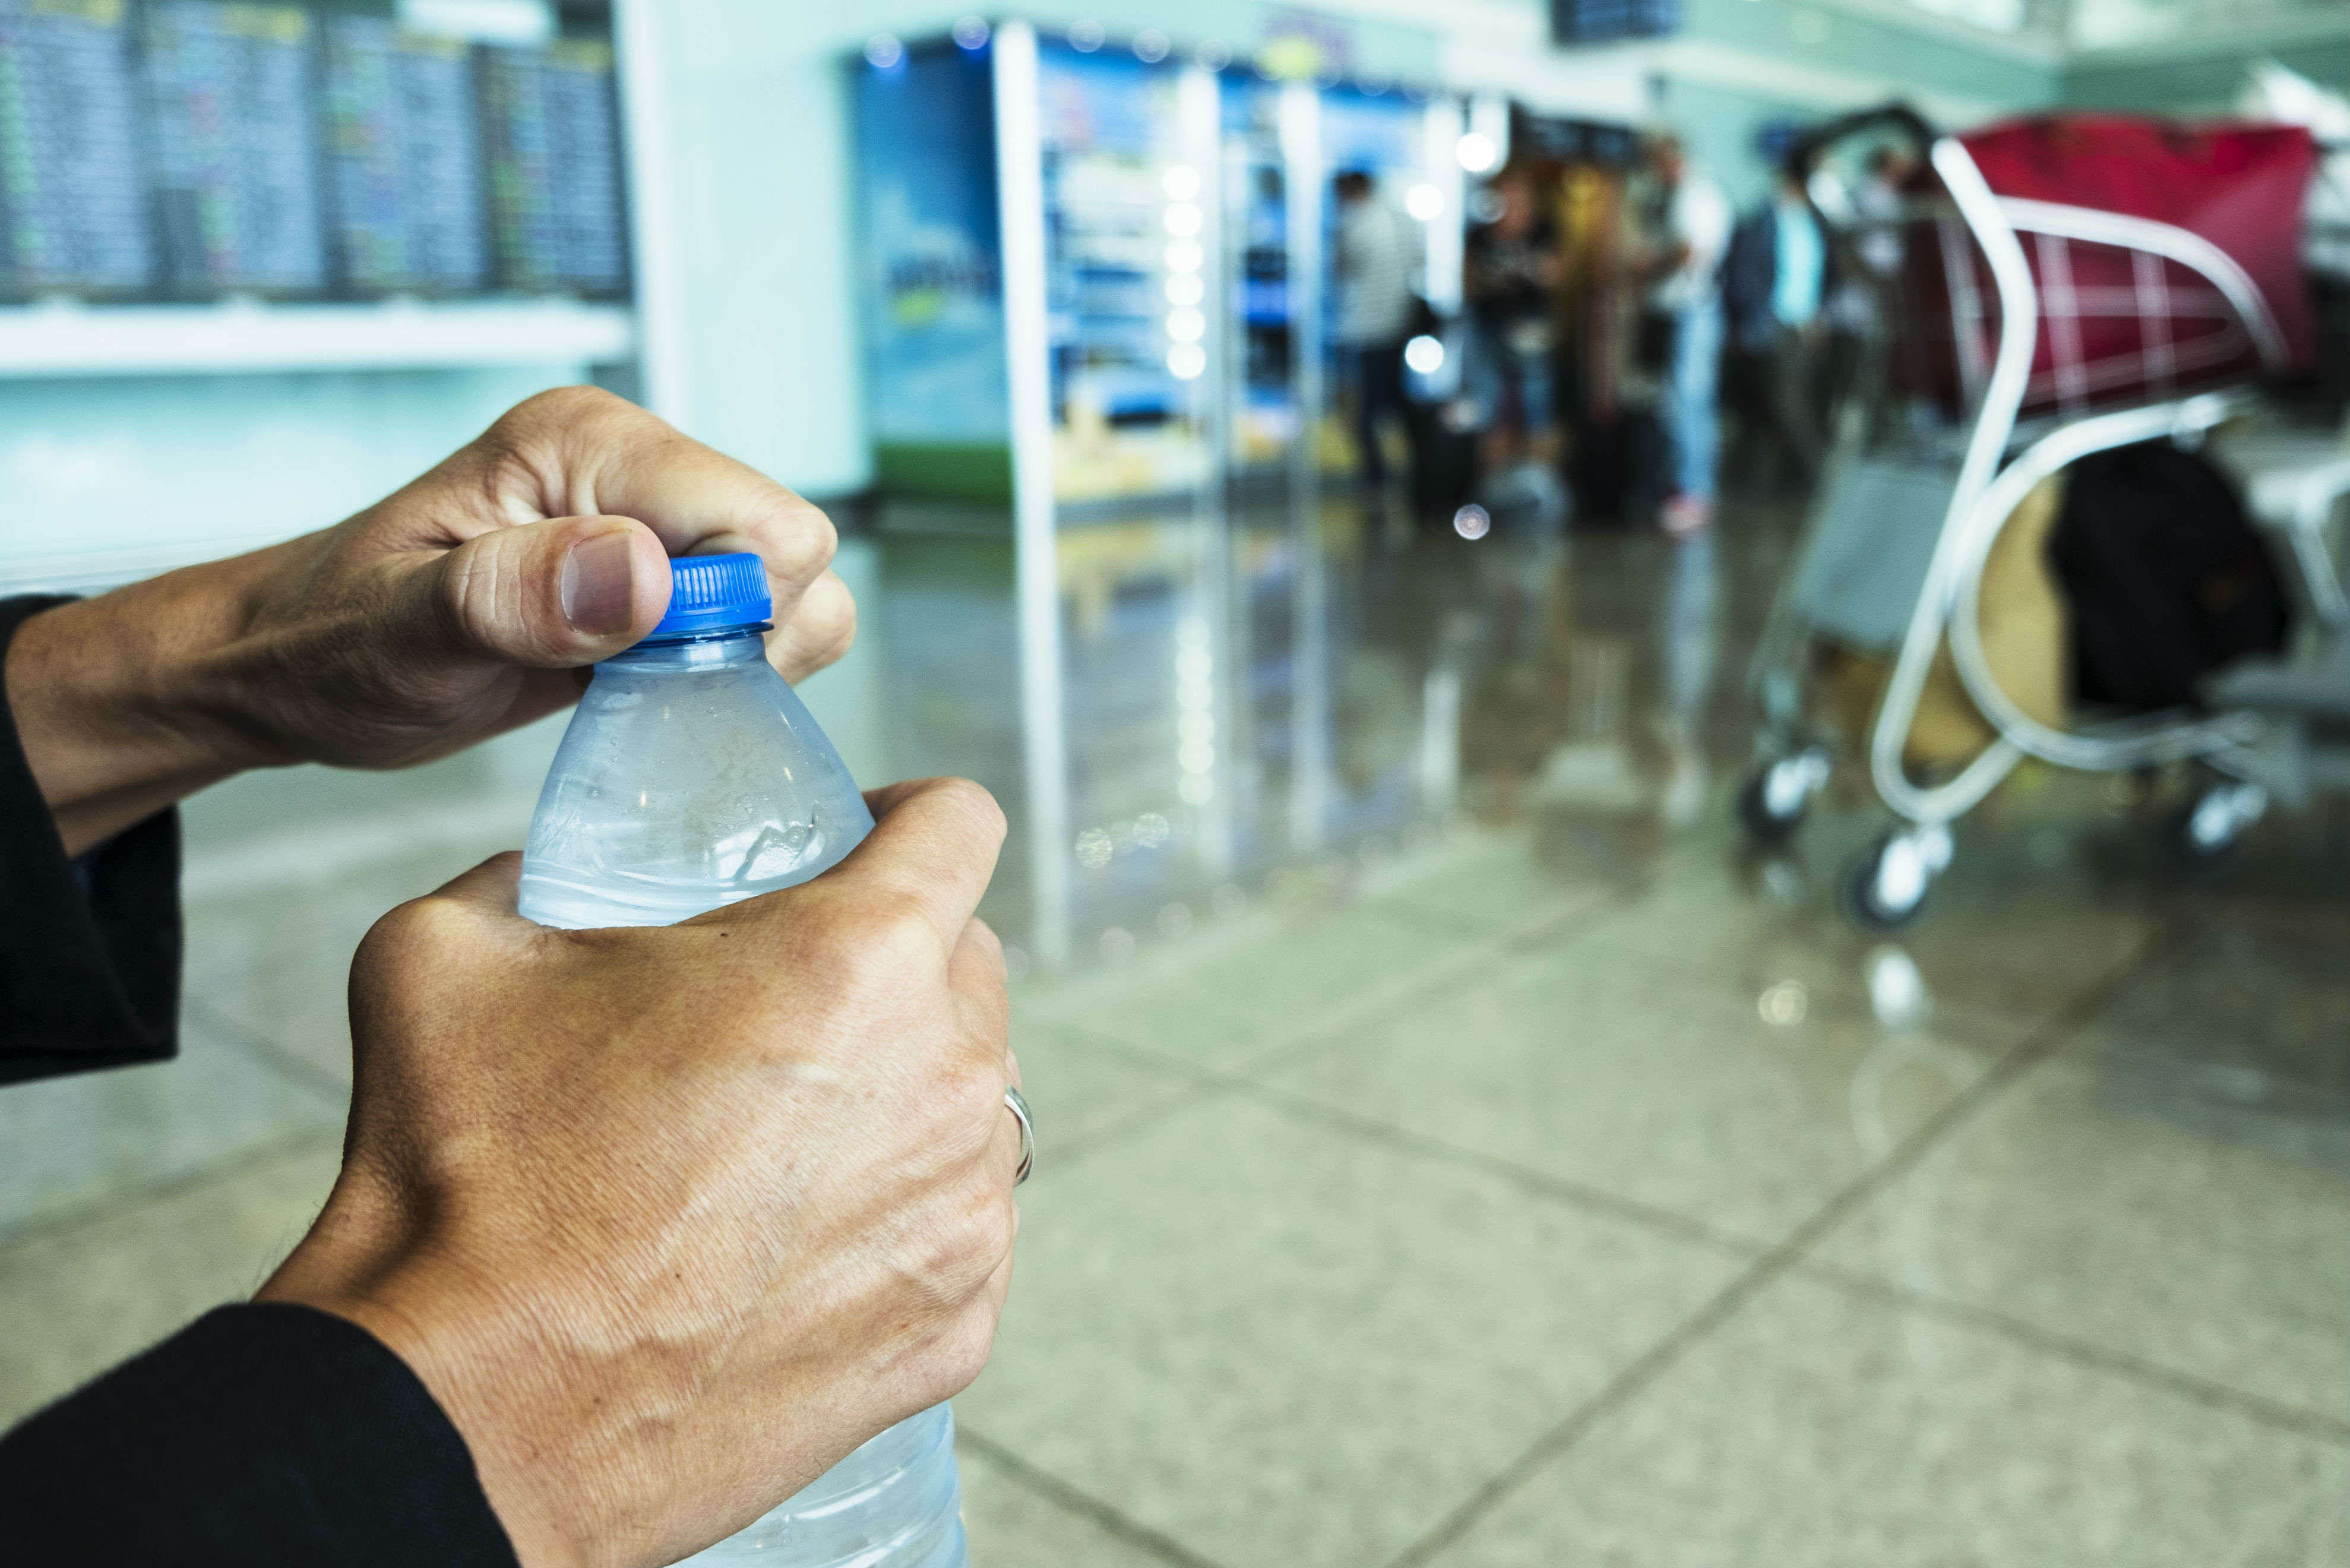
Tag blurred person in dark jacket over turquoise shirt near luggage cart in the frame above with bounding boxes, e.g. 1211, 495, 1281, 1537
1722, 160, 1833, 494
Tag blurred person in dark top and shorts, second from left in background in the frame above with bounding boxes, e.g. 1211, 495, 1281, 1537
1462, 169, 1565, 522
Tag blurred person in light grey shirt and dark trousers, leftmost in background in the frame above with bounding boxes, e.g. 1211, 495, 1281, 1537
1330, 169, 1422, 508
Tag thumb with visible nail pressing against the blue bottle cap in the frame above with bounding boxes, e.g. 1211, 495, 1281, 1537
432, 517, 670, 668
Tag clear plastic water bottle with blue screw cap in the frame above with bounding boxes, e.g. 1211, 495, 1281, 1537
521, 555, 970, 1568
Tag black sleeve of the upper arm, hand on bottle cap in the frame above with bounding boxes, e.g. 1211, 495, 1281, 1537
0, 597, 179, 1084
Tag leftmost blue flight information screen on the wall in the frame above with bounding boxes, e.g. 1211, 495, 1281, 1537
0, 0, 155, 299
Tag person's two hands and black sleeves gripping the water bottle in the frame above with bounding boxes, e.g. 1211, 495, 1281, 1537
0, 388, 1020, 1568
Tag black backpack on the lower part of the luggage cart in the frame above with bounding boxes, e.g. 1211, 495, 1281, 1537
2049, 442, 2286, 710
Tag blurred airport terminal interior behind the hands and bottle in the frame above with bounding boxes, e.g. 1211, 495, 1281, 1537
0, 0, 2350, 1568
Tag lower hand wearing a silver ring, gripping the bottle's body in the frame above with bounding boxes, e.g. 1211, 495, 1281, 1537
261, 780, 1020, 1568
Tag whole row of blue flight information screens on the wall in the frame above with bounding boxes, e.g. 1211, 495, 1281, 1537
0, 0, 628, 301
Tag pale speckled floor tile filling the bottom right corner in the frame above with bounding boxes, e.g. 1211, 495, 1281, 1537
1427, 1279, 2350, 1568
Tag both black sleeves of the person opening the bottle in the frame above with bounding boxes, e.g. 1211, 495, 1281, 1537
0, 599, 515, 1568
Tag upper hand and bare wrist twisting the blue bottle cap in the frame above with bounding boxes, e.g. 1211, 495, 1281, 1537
5, 388, 855, 853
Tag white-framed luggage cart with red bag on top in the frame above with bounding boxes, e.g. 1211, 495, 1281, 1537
1737, 108, 2350, 928
